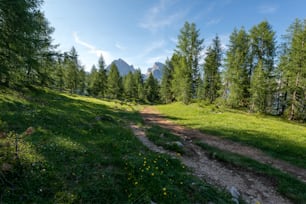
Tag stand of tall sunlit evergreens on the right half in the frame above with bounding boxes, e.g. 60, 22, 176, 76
160, 19, 306, 121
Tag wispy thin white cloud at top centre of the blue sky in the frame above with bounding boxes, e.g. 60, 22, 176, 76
139, 0, 185, 31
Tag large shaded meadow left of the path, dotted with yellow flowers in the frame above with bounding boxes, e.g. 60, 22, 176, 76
0, 88, 231, 203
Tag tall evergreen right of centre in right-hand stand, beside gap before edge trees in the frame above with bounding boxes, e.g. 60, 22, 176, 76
249, 21, 276, 113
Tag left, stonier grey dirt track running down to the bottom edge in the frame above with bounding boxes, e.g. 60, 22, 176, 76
131, 125, 290, 204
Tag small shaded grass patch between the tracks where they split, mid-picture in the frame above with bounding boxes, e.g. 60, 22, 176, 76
146, 125, 185, 154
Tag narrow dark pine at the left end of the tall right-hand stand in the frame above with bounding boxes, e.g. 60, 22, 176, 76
160, 59, 173, 103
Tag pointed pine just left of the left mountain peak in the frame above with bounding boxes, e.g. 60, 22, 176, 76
107, 63, 122, 99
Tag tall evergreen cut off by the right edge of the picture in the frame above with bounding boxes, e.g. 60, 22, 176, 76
279, 19, 306, 120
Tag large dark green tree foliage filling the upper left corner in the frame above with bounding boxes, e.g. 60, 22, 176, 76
0, 0, 54, 85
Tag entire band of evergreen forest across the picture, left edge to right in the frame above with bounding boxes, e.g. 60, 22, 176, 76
0, 0, 306, 121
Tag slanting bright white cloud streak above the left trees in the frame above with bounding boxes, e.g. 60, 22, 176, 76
73, 32, 113, 64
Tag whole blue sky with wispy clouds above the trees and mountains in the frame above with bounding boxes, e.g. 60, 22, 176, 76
42, 0, 306, 72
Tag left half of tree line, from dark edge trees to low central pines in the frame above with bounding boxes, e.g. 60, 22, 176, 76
0, 0, 158, 102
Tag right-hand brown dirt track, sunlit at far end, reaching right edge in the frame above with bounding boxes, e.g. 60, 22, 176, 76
141, 107, 306, 183
